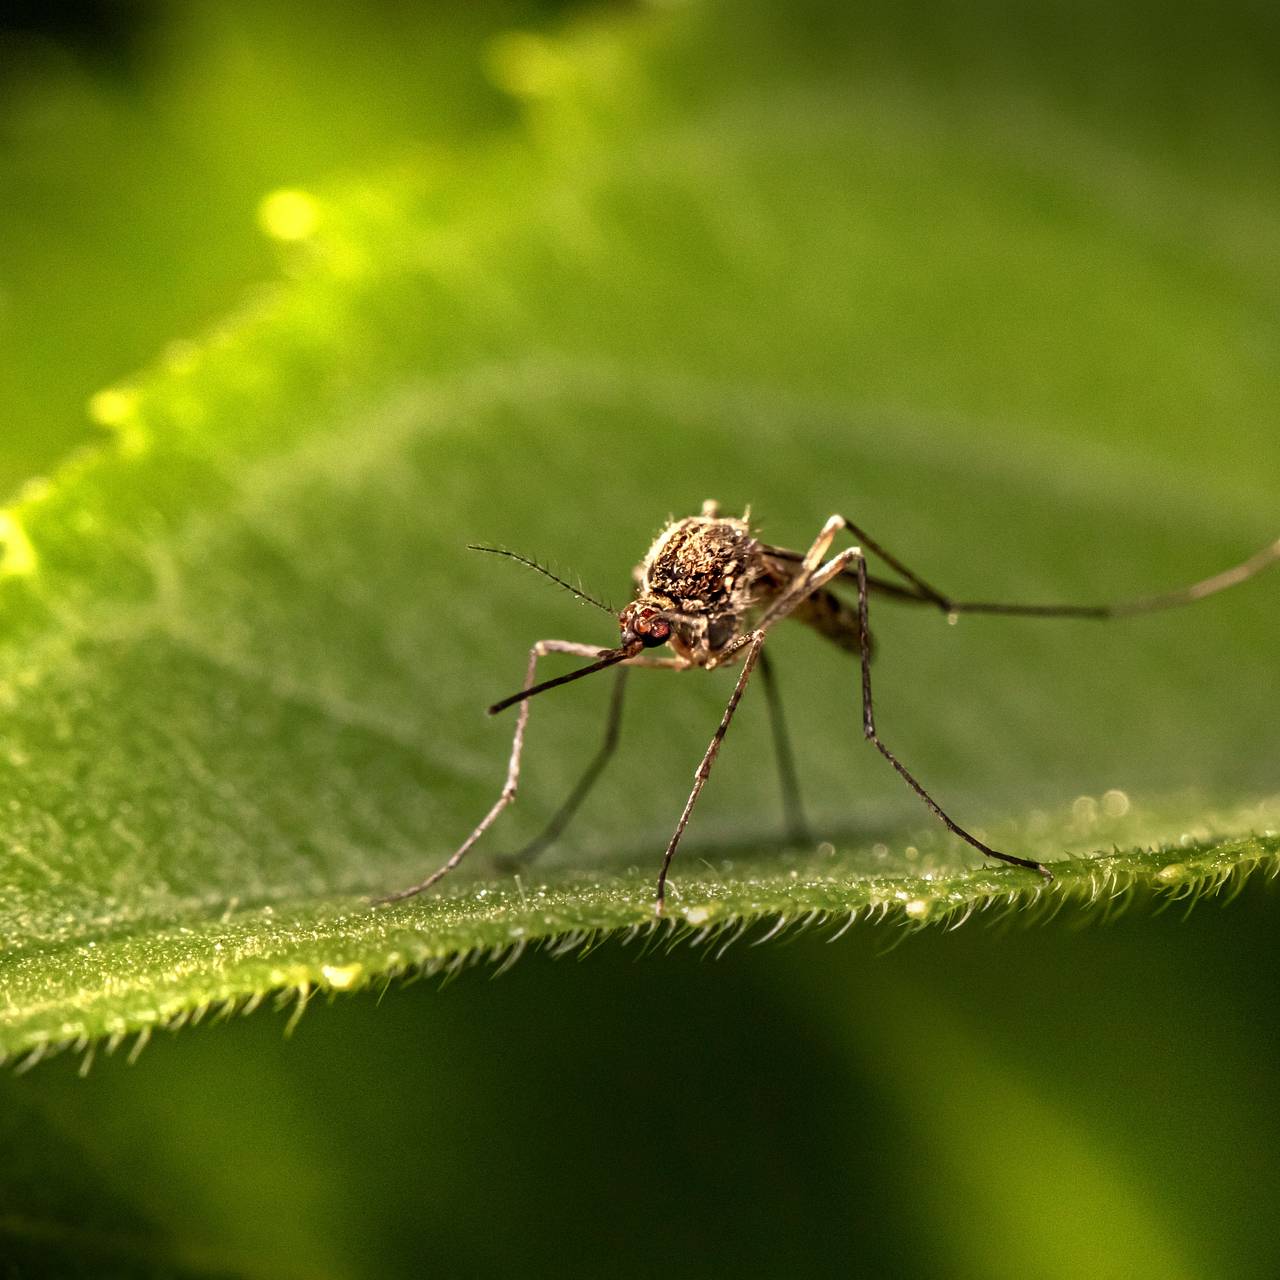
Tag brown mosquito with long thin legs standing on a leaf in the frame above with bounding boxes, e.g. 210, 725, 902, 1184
378, 502, 1280, 915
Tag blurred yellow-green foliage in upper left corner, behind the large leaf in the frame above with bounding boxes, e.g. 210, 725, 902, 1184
0, 0, 529, 494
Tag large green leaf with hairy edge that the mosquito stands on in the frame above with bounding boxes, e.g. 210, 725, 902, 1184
0, 0, 1280, 1056
